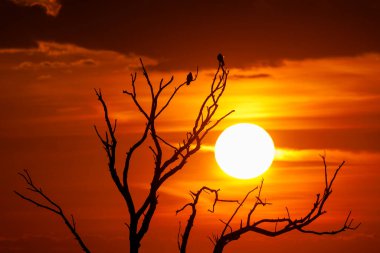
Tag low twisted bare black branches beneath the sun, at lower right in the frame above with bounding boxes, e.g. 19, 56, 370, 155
177, 156, 360, 253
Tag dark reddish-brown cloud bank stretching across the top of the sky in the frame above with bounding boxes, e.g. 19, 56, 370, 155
0, 0, 380, 68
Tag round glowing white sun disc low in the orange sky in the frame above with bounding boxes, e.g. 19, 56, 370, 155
215, 123, 275, 179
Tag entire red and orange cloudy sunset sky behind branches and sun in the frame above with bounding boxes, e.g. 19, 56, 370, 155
0, 0, 380, 253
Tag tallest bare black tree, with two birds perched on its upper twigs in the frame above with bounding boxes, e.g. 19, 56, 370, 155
95, 60, 233, 253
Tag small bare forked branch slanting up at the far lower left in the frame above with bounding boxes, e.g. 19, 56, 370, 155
14, 170, 90, 253
